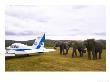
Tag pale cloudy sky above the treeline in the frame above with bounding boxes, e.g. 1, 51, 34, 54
5, 5, 106, 40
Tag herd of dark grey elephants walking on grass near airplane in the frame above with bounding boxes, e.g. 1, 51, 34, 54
55, 39, 103, 60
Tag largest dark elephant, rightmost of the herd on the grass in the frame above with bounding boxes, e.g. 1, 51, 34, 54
83, 39, 103, 60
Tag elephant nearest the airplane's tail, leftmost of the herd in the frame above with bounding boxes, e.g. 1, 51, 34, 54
55, 42, 70, 55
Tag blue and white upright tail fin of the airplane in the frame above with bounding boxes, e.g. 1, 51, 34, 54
33, 34, 45, 49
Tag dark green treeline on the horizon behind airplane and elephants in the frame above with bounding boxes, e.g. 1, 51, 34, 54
5, 39, 106, 49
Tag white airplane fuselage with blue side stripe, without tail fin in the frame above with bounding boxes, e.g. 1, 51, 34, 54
6, 43, 43, 54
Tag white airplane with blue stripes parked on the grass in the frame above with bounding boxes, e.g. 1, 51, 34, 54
5, 33, 56, 56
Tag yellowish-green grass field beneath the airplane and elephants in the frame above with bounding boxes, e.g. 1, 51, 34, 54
5, 49, 106, 72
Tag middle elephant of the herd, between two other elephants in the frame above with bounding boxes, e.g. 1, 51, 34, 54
72, 41, 86, 57
